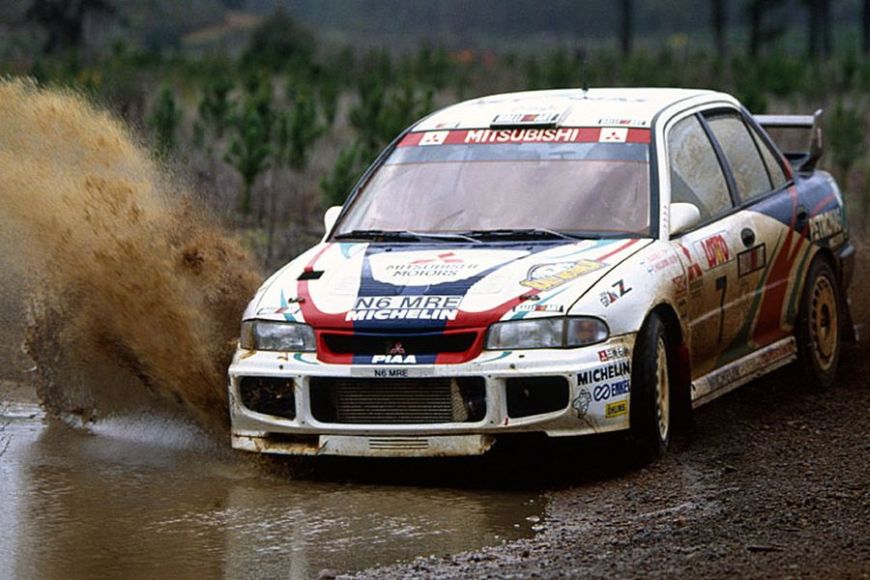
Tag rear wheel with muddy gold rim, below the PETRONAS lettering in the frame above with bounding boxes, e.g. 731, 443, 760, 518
795, 257, 844, 389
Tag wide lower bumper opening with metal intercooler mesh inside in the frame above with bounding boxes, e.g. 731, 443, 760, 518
310, 377, 486, 425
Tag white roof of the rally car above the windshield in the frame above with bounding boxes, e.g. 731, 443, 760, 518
412, 88, 737, 131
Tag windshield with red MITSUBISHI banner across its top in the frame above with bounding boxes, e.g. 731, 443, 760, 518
335, 128, 650, 236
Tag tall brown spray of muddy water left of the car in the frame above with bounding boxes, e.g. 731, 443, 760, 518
0, 80, 260, 430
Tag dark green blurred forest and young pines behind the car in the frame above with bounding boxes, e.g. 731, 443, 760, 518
0, 0, 870, 272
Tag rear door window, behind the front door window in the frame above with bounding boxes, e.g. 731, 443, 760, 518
707, 113, 773, 199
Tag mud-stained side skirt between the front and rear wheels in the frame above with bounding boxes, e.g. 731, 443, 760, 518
692, 336, 797, 409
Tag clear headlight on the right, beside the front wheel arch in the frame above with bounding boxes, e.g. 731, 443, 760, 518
486, 316, 610, 350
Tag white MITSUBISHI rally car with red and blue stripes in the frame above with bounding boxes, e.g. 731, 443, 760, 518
229, 89, 854, 456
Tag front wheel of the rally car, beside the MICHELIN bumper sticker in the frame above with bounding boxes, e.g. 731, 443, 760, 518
629, 314, 674, 462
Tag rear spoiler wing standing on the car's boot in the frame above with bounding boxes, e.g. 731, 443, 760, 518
753, 109, 824, 172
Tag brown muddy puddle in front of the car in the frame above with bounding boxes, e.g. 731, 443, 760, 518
0, 404, 542, 578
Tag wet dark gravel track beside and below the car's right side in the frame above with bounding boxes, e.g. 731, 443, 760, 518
358, 252, 870, 578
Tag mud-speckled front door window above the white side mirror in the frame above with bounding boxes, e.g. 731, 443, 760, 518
668, 116, 731, 220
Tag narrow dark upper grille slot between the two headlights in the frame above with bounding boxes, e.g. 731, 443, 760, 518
323, 332, 478, 355
